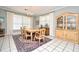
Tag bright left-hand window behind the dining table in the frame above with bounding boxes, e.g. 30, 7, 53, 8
13, 15, 31, 30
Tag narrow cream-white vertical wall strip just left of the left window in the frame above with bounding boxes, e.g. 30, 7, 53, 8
7, 12, 14, 35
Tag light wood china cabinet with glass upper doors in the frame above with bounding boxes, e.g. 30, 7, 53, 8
56, 13, 79, 44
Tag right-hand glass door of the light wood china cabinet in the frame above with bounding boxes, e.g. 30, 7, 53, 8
67, 16, 76, 30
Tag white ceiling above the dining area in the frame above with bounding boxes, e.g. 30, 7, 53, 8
0, 6, 64, 15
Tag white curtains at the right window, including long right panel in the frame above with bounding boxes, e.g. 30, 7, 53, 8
39, 13, 56, 36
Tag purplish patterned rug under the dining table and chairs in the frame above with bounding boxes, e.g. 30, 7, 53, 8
13, 35, 51, 52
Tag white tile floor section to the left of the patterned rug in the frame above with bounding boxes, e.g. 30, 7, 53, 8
0, 36, 17, 52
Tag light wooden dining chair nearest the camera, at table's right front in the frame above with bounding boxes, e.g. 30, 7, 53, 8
34, 29, 45, 45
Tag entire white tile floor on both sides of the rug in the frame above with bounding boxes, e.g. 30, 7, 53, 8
0, 35, 79, 52
